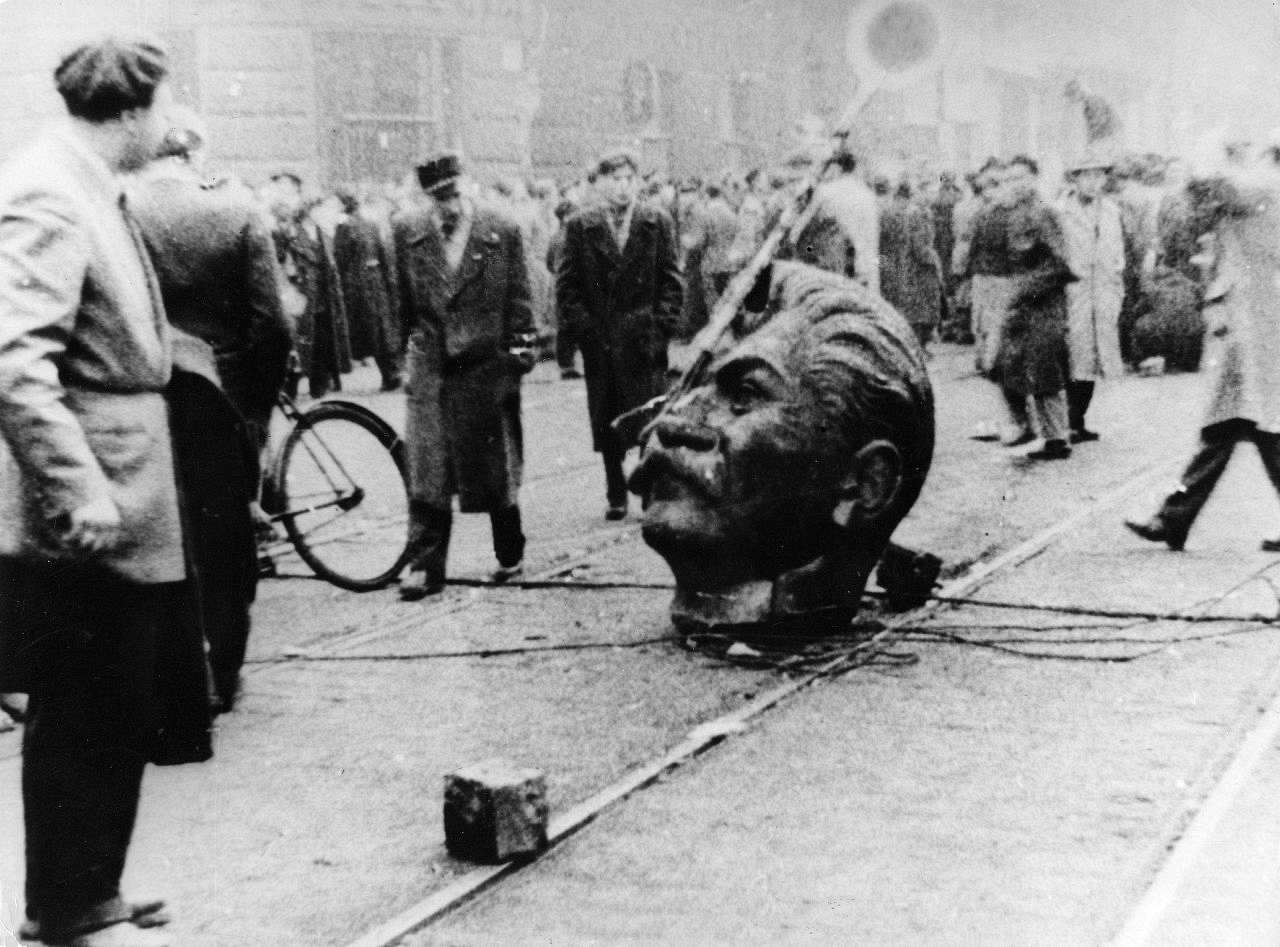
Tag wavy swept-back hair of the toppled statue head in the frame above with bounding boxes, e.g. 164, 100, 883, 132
758, 262, 934, 525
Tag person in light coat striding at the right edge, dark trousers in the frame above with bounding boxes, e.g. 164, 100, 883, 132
1125, 148, 1280, 552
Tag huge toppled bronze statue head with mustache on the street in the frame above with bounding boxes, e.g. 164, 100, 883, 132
631, 262, 933, 630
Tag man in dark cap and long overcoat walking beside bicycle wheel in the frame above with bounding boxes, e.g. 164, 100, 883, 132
393, 154, 536, 600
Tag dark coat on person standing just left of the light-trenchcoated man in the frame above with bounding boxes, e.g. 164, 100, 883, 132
997, 196, 1076, 395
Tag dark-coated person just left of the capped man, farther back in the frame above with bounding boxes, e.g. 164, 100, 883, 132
333, 191, 401, 392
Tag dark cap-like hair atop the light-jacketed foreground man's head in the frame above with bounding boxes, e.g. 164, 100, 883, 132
54, 37, 169, 123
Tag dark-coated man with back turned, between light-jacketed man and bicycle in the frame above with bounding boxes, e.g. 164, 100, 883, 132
129, 115, 293, 710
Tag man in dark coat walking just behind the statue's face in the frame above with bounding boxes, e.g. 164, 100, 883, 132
557, 151, 684, 520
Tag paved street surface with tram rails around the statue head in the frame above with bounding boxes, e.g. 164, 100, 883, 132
0, 347, 1280, 947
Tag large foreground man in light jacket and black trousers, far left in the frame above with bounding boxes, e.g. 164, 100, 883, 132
0, 40, 211, 947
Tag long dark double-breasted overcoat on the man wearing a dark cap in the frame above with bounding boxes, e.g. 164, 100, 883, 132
394, 198, 535, 513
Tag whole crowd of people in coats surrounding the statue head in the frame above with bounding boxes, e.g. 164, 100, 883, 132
0, 29, 1254, 947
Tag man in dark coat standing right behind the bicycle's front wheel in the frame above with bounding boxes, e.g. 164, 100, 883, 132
271, 171, 351, 398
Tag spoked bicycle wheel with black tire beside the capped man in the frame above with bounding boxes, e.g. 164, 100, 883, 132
273, 401, 410, 591
